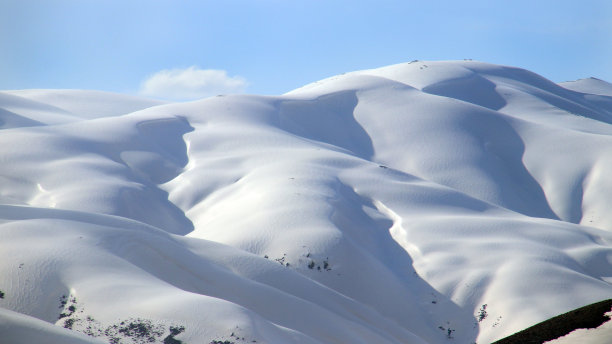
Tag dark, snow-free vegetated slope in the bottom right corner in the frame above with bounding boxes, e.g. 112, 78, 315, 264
493, 299, 612, 344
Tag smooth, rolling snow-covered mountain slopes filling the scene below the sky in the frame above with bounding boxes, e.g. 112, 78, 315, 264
0, 61, 612, 344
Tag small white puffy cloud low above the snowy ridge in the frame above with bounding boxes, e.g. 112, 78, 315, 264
140, 66, 247, 100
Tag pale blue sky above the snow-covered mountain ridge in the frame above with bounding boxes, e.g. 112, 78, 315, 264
0, 0, 612, 98
